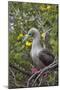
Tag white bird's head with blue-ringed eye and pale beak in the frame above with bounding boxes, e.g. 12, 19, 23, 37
23, 28, 40, 42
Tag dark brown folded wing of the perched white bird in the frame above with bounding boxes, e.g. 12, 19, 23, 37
39, 49, 54, 66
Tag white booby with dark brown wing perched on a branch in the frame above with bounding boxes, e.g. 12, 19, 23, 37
24, 28, 54, 72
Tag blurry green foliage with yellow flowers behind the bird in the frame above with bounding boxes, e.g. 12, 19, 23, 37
8, 2, 58, 88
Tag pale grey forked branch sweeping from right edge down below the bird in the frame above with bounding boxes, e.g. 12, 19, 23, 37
27, 60, 58, 87
